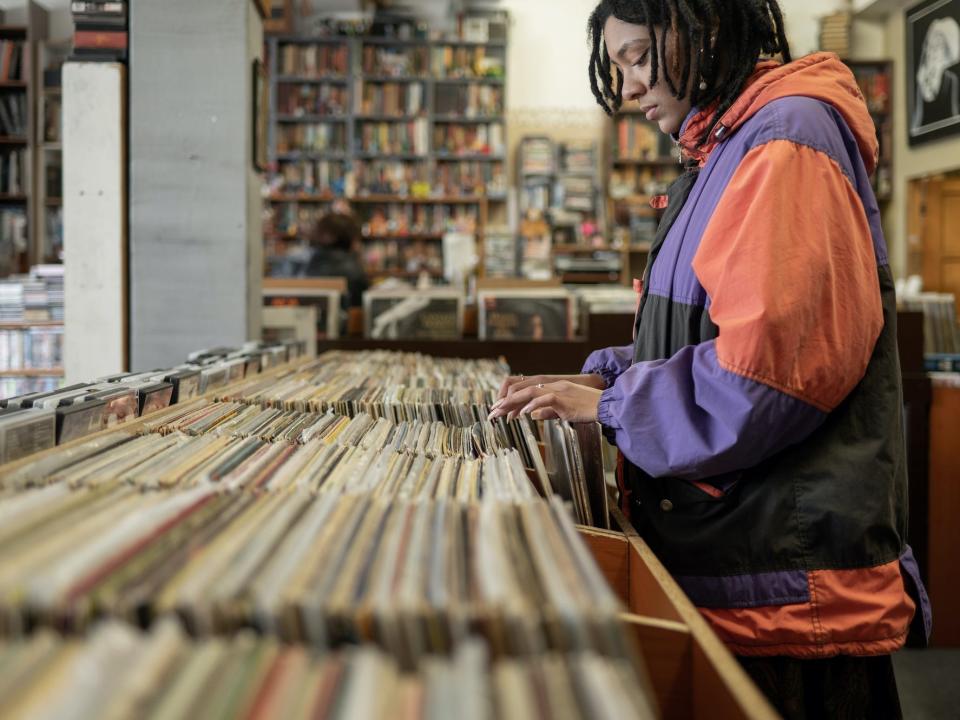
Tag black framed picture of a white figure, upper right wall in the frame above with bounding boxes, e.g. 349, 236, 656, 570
905, 0, 960, 145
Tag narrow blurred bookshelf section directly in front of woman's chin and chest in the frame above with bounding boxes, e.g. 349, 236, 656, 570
607, 110, 682, 285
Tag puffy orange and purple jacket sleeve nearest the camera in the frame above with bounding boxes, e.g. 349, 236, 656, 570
599, 140, 883, 480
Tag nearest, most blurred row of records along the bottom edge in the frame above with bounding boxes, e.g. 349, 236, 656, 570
0, 619, 656, 720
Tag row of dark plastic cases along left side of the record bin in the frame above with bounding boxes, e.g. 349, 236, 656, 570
0, 343, 303, 463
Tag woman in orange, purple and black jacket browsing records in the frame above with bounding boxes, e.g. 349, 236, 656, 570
491, 0, 929, 718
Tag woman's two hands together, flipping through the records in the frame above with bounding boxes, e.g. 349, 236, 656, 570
488, 376, 603, 422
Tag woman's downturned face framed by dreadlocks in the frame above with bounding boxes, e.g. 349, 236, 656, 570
603, 16, 693, 133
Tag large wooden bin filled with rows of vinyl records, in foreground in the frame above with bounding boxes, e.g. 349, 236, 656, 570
0, 347, 775, 719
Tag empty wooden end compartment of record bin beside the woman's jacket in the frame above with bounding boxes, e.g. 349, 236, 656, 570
578, 507, 779, 720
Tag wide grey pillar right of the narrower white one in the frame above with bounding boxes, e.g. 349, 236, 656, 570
129, 0, 263, 370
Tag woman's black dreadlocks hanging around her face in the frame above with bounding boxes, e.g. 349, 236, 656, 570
587, 0, 790, 145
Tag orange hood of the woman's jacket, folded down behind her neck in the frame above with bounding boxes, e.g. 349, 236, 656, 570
680, 53, 879, 174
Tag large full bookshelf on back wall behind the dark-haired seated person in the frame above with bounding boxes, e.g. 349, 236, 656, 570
264, 11, 507, 278
